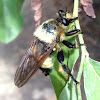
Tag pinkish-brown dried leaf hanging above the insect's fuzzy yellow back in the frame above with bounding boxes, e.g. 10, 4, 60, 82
31, 0, 42, 27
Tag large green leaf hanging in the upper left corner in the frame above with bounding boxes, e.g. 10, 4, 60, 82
0, 0, 23, 43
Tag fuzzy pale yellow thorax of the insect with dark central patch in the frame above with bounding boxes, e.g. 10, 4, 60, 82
33, 19, 62, 44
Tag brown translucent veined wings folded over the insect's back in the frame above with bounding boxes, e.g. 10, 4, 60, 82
14, 37, 56, 87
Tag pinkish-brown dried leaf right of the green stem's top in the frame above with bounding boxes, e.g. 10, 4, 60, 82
80, 0, 96, 18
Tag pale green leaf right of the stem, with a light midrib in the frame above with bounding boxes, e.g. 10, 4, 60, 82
84, 58, 100, 100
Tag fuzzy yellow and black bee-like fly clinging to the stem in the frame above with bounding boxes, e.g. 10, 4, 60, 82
14, 10, 80, 87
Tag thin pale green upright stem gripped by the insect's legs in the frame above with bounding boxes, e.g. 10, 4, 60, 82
73, 0, 88, 100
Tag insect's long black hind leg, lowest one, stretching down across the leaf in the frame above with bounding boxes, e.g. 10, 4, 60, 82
57, 50, 79, 85
